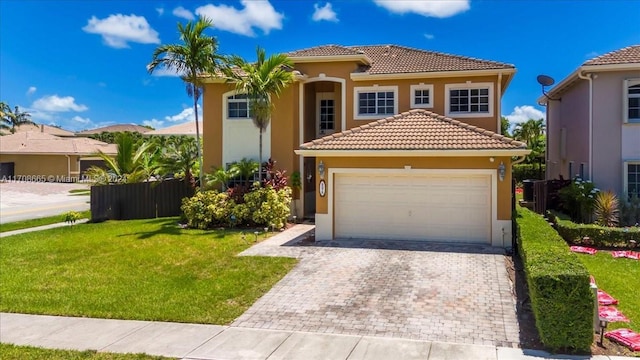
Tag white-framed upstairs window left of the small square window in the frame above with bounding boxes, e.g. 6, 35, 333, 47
354, 86, 398, 119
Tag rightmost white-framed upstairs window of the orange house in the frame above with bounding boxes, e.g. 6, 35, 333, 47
445, 83, 493, 117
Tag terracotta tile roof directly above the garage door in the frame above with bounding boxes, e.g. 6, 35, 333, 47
300, 109, 526, 150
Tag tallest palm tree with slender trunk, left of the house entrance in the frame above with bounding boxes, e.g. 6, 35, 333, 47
147, 17, 221, 185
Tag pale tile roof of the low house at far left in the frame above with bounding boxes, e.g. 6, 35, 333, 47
0, 131, 118, 155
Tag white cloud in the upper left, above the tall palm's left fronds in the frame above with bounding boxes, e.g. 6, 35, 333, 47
82, 14, 160, 48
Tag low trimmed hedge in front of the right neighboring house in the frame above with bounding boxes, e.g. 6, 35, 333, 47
551, 212, 640, 248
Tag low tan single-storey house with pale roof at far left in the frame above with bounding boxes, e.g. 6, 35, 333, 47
0, 132, 117, 182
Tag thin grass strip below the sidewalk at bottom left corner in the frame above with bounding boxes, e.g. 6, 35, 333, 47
0, 344, 169, 360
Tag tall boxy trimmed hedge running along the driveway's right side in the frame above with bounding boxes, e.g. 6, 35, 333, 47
517, 207, 595, 352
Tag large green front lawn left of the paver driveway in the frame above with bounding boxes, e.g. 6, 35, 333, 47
0, 218, 296, 324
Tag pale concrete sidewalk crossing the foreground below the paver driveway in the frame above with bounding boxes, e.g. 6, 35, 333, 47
0, 313, 631, 360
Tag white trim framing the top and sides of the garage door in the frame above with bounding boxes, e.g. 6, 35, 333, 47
324, 167, 504, 246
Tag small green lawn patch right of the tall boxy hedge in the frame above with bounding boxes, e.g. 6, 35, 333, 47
577, 251, 640, 331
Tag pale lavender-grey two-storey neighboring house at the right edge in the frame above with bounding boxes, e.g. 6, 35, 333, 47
538, 45, 640, 200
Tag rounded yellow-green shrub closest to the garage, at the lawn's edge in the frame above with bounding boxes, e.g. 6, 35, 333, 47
244, 186, 291, 229
